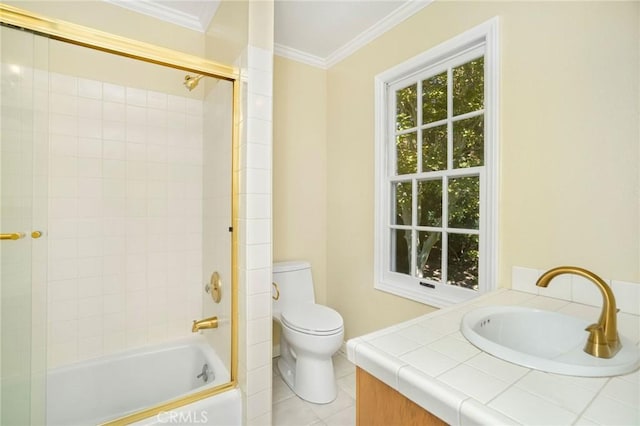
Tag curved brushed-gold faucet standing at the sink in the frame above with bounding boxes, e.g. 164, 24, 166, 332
536, 266, 622, 358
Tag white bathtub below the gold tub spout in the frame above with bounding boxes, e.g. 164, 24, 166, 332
47, 336, 241, 426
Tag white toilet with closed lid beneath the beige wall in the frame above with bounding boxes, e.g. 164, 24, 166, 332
273, 261, 344, 404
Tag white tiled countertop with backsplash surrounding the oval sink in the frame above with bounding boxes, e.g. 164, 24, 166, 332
347, 289, 640, 425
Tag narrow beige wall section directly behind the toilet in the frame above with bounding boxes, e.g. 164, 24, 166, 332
273, 56, 327, 303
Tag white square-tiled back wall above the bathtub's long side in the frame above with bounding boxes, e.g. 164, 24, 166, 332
48, 74, 203, 367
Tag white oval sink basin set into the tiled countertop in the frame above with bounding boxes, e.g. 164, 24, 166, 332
460, 306, 640, 377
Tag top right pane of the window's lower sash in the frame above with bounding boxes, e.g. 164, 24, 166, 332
448, 176, 480, 229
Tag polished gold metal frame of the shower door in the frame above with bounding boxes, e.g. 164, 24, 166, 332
0, 3, 241, 426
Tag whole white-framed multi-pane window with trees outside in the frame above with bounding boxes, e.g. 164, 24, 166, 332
375, 18, 498, 306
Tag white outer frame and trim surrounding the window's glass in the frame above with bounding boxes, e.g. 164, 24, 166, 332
374, 17, 500, 307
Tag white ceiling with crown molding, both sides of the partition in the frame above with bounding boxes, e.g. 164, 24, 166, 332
105, 0, 431, 68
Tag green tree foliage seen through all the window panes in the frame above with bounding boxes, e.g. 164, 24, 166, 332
392, 58, 484, 289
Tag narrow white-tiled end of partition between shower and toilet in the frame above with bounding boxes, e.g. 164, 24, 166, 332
238, 46, 273, 426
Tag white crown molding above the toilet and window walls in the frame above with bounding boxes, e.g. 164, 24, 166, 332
275, 0, 433, 69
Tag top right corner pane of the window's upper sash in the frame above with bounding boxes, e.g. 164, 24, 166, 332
453, 57, 484, 116
